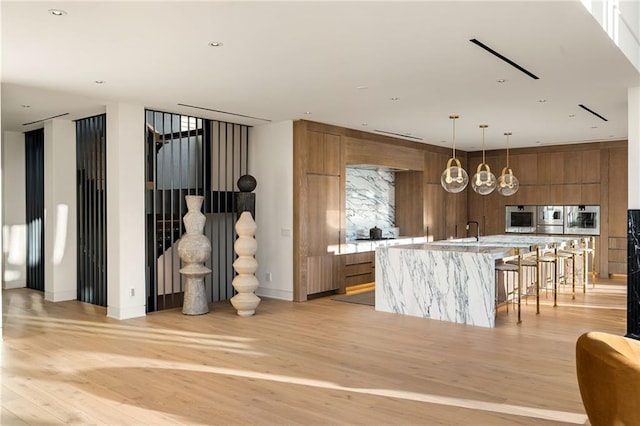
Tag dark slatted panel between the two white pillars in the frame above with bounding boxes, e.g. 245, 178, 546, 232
76, 114, 107, 306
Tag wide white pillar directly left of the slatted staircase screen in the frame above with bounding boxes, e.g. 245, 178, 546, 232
107, 103, 146, 319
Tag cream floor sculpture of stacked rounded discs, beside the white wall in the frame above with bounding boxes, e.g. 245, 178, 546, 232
231, 211, 260, 317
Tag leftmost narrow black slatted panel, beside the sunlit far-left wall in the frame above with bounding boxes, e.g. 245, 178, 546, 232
25, 129, 44, 291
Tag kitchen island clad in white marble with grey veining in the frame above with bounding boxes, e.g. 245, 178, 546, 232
375, 235, 572, 327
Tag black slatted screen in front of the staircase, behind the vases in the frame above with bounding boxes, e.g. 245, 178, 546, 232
146, 110, 249, 311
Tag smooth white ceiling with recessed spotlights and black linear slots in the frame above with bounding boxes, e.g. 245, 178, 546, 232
0, 0, 640, 150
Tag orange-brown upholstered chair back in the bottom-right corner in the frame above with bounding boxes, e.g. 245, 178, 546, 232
576, 332, 640, 426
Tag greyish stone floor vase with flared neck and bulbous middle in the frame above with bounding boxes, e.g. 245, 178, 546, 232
178, 195, 211, 315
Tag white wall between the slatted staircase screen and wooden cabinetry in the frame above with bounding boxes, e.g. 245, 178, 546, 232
249, 121, 293, 300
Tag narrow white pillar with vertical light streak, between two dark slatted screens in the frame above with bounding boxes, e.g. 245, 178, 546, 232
44, 119, 77, 302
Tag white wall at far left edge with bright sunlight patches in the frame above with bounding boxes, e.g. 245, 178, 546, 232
2, 132, 27, 289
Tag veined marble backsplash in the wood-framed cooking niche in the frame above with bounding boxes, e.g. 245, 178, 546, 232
345, 167, 398, 241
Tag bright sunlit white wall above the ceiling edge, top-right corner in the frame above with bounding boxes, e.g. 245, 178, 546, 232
581, 0, 640, 70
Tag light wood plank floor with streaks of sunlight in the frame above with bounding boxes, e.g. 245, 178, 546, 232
0, 280, 626, 426
